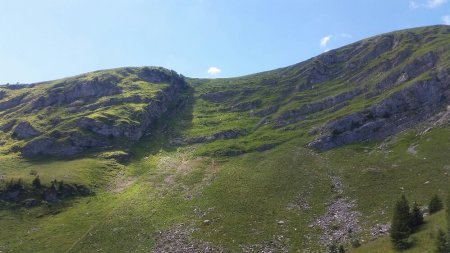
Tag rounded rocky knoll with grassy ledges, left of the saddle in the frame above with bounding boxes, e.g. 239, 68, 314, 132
0, 67, 187, 157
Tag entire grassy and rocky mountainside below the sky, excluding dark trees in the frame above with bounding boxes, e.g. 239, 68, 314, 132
0, 26, 450, 252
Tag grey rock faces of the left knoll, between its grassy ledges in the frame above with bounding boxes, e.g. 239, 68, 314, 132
21, 68, 186, 157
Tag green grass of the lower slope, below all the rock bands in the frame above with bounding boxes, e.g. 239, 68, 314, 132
0, 122, 450, 252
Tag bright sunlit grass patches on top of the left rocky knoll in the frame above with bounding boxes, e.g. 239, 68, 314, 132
0, 68, 177, 154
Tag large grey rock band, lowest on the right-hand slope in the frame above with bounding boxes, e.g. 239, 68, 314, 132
309, 69, 450, 150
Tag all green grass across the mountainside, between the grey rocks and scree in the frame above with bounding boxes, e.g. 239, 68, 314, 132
0, 24, 450, 252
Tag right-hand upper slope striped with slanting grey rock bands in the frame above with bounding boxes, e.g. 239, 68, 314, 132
193, 26, 450, 153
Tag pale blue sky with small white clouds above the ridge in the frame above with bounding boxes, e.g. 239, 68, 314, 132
0, 0, 450, 83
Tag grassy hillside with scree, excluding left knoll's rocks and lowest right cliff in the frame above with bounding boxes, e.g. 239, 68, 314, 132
0, 26, 450, 252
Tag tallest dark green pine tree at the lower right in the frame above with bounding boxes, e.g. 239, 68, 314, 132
391, 195, 411, 250
